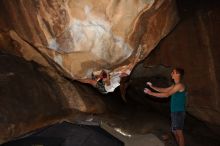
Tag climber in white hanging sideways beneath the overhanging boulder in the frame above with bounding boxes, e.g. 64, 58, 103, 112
78, 46, 142, 101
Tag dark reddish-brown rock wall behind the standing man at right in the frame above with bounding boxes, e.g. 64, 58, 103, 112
145, 1, 220, 125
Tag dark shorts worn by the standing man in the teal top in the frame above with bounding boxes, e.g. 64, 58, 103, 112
171, 112, 185, 131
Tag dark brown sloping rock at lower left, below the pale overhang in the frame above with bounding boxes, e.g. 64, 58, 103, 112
0, 54, 105, 143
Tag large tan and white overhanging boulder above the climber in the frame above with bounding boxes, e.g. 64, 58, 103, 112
0, 0, 178, 79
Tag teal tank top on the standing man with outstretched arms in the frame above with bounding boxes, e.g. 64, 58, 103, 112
170, 91, 186, 112
